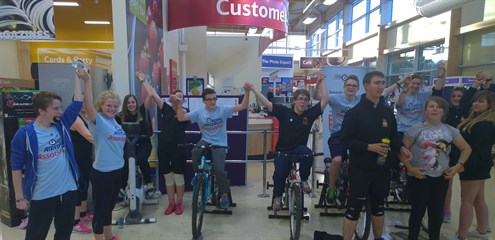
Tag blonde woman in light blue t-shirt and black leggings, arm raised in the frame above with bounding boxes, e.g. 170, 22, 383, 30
77, 68, 126, 240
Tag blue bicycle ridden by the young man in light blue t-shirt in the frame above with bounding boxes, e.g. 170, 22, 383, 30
179, 143, 232, 239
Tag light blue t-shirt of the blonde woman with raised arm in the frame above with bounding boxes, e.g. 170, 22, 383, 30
89, 113, 126, 172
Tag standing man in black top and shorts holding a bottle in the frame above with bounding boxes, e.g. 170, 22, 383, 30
340, 71, 412, 240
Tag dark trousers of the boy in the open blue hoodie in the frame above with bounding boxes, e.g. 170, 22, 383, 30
25, 191, 77, 240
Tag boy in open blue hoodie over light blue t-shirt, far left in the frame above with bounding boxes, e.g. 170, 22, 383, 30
10, 72, 87, 240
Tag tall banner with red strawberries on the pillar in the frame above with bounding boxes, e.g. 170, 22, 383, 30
126, 0, 165, 103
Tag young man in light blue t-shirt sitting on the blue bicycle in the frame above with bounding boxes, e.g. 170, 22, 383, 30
175, 86, 249, 208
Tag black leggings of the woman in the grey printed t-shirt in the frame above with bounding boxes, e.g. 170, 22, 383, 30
407, 176, 449, 240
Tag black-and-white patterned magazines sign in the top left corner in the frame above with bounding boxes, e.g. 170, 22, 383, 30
0, 0, 55, 40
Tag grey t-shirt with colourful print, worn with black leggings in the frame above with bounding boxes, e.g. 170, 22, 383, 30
404, 123, 460, 177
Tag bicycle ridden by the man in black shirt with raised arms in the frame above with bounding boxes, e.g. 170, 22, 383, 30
269, 152, 323, 240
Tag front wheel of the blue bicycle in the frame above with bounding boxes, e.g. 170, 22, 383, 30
192, 174, 206, 239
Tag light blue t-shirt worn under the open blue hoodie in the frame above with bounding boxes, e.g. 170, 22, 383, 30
32, 123, 77, 200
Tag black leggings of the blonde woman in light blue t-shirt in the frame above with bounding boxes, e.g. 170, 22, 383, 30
91, 168, 122, 234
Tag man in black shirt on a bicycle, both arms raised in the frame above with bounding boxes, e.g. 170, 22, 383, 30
247, 79, 328, 212
